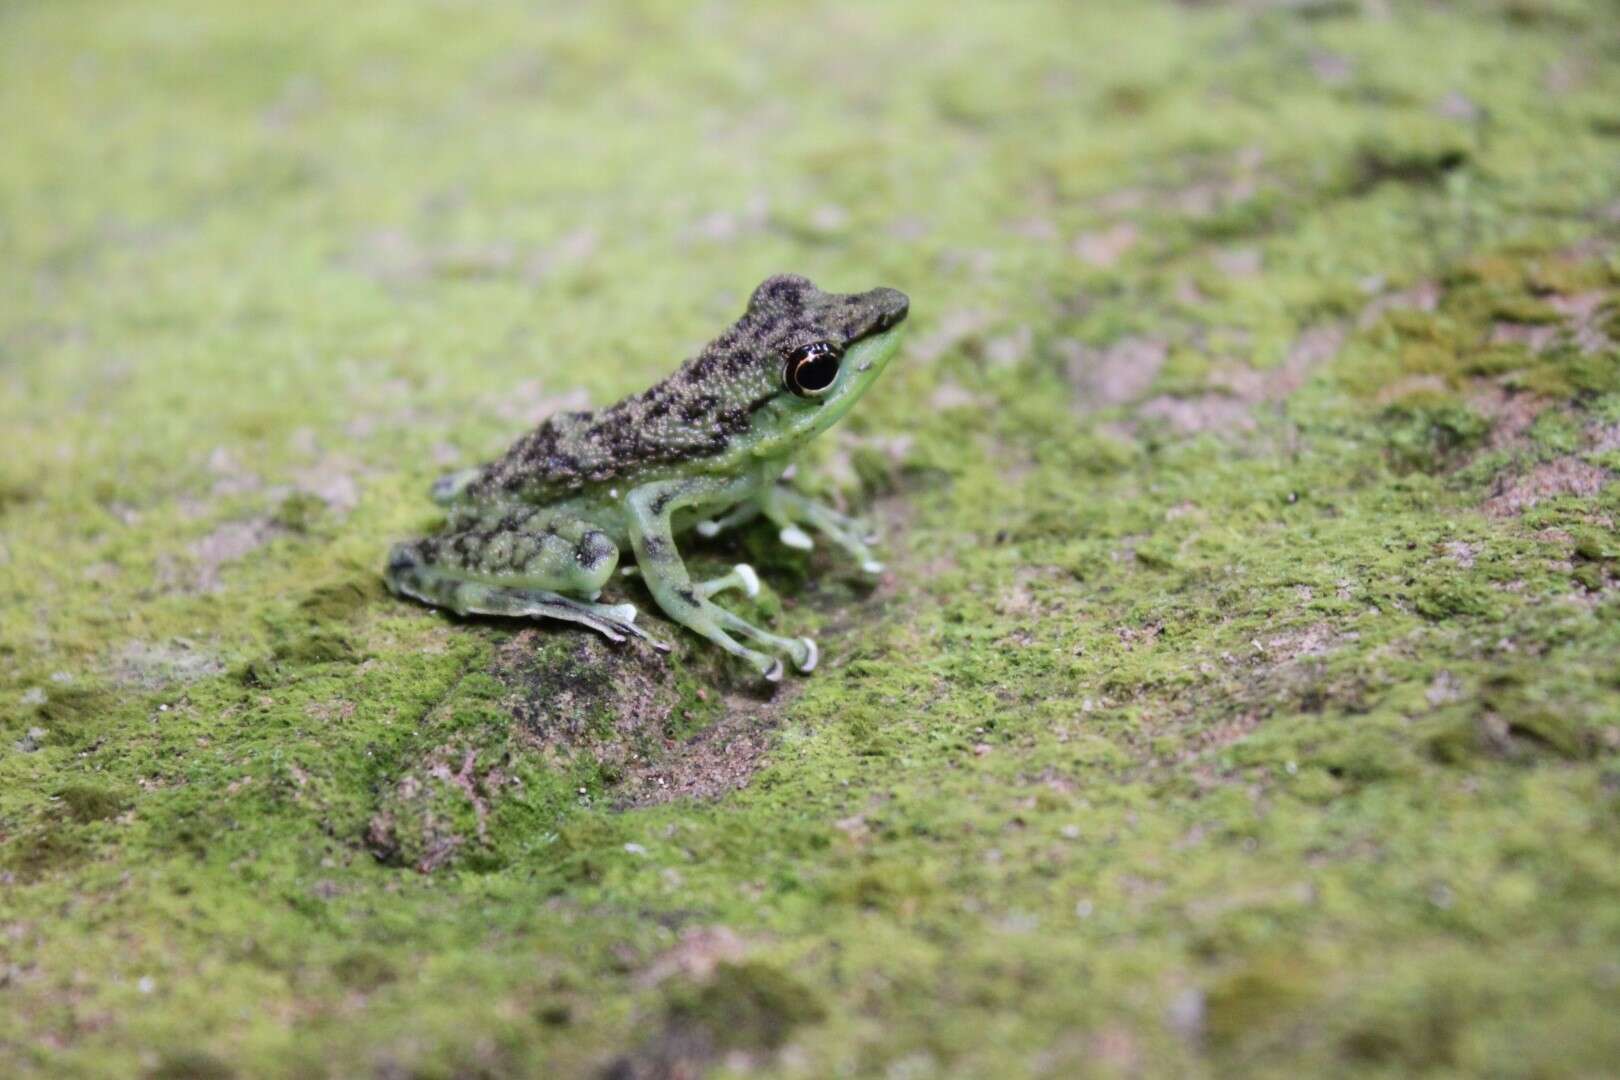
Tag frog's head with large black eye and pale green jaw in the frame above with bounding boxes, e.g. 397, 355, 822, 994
731, 274, 910, 450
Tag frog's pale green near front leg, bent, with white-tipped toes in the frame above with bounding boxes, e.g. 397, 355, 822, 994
625, 478, 818, 682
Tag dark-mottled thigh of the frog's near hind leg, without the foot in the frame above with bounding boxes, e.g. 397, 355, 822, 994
387, 508, 619, 599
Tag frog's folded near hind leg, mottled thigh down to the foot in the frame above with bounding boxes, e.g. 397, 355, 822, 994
387, 508, 669, 649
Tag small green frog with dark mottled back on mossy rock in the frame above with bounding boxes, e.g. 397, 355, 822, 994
384, 274, 910, 683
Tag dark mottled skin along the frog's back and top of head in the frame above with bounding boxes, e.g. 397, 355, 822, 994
462, 274, 909, 502
